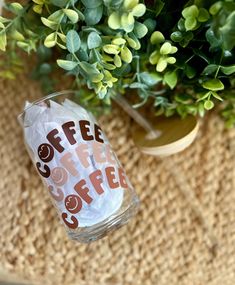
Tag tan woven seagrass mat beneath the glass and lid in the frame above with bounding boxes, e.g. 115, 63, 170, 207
0, 69, 235, 285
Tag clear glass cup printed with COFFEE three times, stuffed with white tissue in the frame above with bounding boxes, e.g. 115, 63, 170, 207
18, 91, 139, 242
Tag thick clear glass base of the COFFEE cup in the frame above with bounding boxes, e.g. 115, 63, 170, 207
68, 198, 139, 243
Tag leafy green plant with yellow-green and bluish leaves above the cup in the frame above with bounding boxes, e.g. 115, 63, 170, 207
0, 0, 235, 126
